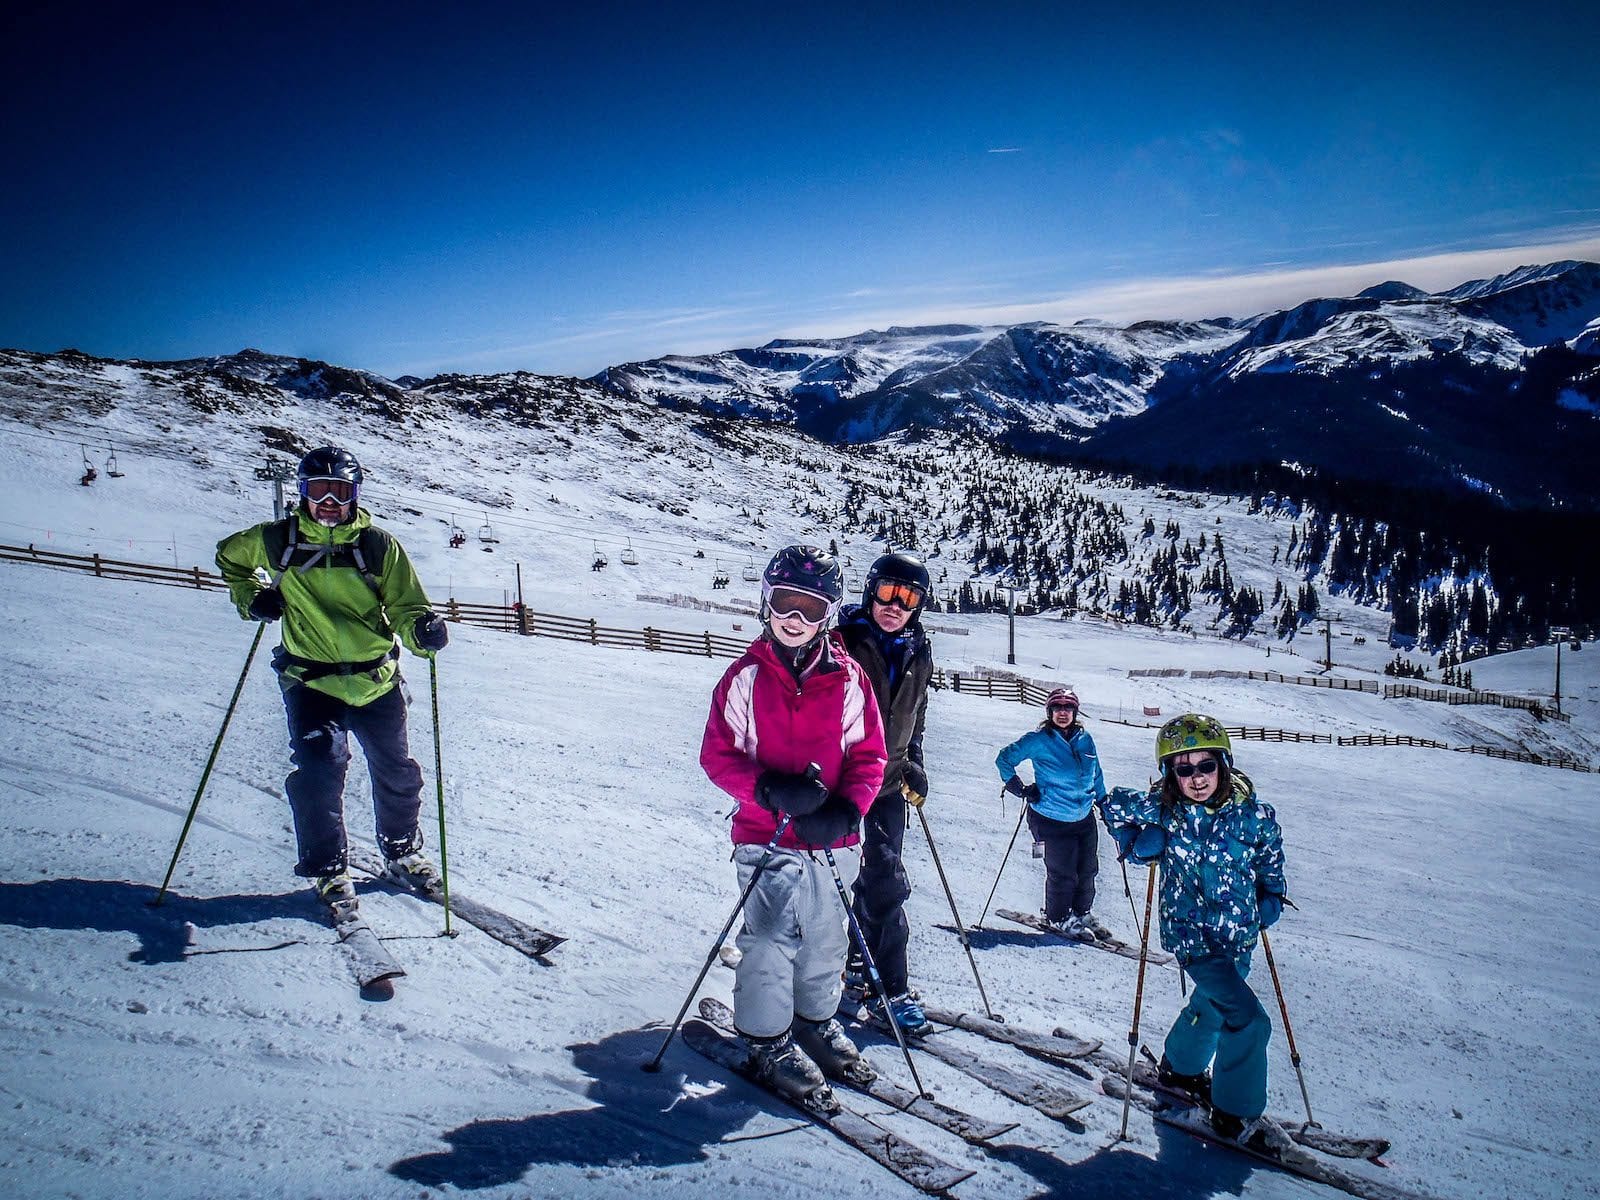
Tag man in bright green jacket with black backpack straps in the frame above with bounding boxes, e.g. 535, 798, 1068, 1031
216, 446, 450, 904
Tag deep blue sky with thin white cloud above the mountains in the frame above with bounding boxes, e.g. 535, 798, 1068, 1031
0, 2, 1600, 376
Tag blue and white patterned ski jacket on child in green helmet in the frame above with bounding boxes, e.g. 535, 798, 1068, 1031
1099, 771, 1286, 963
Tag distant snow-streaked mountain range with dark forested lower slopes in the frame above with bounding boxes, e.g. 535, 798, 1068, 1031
595, 262, 1600, 507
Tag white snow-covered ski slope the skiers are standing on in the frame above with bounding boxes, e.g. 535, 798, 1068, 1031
0, 377, 1600, 1200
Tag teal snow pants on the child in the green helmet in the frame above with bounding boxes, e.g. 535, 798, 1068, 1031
1165, 955, 1272, 1120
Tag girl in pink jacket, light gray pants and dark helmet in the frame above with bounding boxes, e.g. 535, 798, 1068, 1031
701, 546, 885, 1110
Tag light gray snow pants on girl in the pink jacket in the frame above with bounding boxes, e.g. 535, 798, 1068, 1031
733, 845, 858, 1037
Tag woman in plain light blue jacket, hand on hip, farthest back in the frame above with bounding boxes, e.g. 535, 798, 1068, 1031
995, 688, 1112, 941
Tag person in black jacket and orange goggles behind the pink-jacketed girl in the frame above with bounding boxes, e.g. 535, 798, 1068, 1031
838, 554, 933, 1034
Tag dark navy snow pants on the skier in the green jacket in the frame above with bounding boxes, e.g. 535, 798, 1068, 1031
283, 683, 422, 878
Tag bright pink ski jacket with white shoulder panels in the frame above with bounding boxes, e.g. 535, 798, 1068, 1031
701, 637, 886, 848
